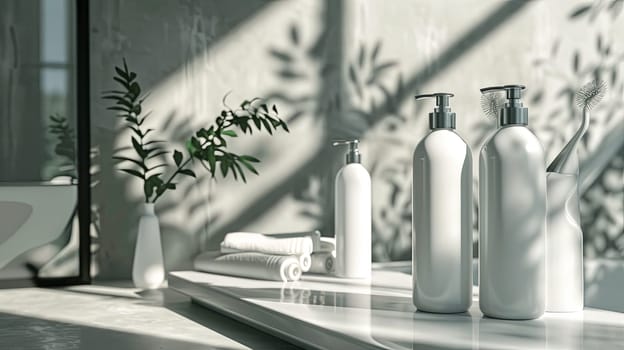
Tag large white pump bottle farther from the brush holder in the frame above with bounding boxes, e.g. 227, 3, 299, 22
412, 93, 473, 313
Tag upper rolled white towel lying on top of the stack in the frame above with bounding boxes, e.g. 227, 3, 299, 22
221, 232, 314, 255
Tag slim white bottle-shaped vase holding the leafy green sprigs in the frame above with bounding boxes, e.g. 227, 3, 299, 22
132, 203, 165, 289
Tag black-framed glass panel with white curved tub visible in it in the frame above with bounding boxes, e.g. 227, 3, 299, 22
0, 0, 90, 287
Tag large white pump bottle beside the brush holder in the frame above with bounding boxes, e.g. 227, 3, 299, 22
479, 85, 546, 319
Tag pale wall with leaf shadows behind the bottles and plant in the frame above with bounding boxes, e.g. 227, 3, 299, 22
91, 0, 624, 278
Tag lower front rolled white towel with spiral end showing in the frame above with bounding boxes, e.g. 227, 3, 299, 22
194, 251, 301, 282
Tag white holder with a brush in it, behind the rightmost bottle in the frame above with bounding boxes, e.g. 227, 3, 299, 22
546, 173, 584, 312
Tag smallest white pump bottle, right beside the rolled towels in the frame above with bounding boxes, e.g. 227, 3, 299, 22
333, 140, 372, 279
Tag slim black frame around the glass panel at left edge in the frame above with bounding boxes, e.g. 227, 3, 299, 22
0, 0, 91, 288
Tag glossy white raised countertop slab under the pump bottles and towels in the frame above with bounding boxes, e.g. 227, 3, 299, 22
169, 270, 624, 350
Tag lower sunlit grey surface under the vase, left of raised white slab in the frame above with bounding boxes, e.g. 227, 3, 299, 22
0, 284, 298, 350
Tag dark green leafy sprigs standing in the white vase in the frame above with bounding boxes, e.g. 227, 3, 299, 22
103, 59, 288, 203
